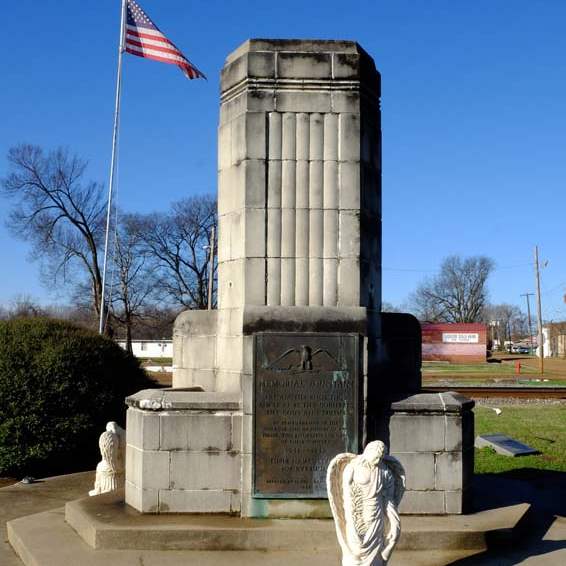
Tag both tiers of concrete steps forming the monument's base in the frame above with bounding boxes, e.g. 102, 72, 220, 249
8, 493, 529, 566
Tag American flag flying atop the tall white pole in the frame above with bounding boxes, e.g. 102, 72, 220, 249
124, 0, 206, 79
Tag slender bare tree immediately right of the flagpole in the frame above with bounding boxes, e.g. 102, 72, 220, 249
110, 215, 156, 352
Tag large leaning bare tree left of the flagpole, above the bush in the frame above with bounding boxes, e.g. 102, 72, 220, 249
2, 144, 105, 313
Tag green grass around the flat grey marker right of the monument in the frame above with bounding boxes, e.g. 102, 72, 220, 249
474, 405, 566, 474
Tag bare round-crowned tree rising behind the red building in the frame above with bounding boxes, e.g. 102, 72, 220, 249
411, 255, 494, 322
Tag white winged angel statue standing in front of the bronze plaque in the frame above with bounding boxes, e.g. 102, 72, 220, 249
326, 440, 405, 566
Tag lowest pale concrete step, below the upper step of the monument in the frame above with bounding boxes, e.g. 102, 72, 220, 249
8, 508, 478, 566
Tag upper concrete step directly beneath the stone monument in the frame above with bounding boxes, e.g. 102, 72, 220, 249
65, 493, 529, 552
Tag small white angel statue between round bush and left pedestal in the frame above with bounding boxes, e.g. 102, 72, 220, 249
88, 421, 126, 495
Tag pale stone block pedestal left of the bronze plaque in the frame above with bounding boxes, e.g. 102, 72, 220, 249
126, 389, 242, 513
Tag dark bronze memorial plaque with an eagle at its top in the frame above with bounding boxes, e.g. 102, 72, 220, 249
253, 333, 362, 498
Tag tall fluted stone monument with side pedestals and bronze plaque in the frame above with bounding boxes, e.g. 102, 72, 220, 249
126, 39, 473, 518
